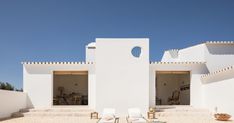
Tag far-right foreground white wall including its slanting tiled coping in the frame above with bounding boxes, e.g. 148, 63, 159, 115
202, 69, 234, 116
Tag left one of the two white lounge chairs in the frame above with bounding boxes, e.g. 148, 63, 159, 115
97, 108, 119, 123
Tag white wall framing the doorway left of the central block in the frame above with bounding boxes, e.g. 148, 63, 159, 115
23, 64, 95, 108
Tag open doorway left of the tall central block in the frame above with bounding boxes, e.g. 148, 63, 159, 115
53, 71, 88, 105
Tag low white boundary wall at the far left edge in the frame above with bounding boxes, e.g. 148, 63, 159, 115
0, 89, 27, 119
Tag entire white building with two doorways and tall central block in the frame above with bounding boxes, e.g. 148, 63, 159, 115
23, 38, 234, 115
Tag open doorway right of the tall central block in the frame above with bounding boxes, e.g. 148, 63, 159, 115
156, 71, 190, 105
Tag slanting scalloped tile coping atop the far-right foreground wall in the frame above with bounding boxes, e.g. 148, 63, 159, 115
201, 65, 234, 83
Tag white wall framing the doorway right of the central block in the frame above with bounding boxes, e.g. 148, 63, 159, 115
149, 64, 208, 107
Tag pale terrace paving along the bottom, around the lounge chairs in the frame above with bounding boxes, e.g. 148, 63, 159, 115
0, 114, 234, 123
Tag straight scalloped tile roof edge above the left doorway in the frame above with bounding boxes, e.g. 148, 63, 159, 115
21, 62, 94, 65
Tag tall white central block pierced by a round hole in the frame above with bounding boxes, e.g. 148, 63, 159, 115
96, 38, 149, 116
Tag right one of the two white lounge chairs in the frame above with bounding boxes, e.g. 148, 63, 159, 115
127, 108, 148, 123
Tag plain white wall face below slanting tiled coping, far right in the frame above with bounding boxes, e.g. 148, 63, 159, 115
203, 78, 234, 116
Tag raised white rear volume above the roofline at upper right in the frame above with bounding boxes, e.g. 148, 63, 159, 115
162, 43, 234, 72
